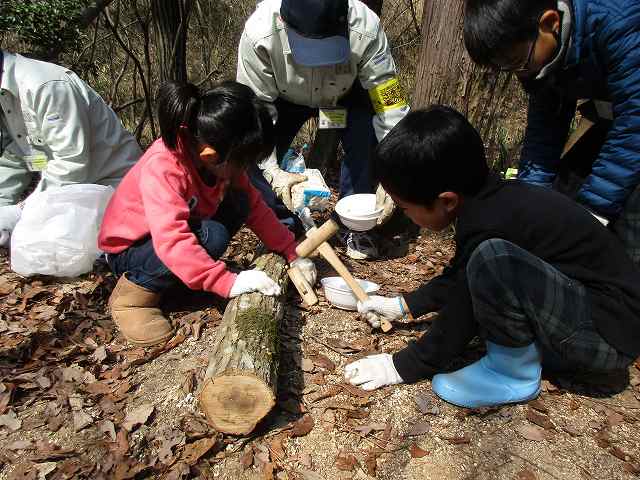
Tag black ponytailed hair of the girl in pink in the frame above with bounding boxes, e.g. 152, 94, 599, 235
158, 81, 275, 167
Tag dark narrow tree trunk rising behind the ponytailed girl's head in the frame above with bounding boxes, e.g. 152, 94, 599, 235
151, 0, 193, 83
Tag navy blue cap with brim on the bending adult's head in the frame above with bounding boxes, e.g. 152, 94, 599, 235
280, 0, 351, 67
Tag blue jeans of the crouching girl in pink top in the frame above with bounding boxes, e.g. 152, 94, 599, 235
107, 190, 249, 293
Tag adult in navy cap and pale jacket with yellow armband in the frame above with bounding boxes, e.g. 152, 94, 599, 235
237, 0, 409, 258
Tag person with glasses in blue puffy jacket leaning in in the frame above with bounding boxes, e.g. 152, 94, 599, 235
464, 0, 640, 263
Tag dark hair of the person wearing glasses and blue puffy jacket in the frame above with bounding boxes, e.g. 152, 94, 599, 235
464, 0, 558, 66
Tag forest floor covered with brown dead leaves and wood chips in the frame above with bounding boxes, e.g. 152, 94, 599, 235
0, 199, 640, 480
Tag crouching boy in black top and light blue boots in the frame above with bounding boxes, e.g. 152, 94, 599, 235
345, 107, 640, 408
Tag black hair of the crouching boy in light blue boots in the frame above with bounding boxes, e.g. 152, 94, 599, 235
372, 105, 489, 205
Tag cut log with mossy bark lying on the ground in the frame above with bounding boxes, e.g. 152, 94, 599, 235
199, 253, 287, 435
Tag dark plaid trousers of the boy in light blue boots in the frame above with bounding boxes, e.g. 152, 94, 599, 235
467, 238, 634, 371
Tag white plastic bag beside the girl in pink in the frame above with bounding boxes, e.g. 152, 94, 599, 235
11, 184, 113, 277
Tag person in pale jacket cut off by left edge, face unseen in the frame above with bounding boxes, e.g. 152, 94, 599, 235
0, 50, 141, 246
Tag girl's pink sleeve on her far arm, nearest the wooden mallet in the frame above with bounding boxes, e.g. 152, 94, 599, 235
238, 174, 298, 262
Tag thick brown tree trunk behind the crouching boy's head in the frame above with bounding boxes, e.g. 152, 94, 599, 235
413, 0, 526, 170
